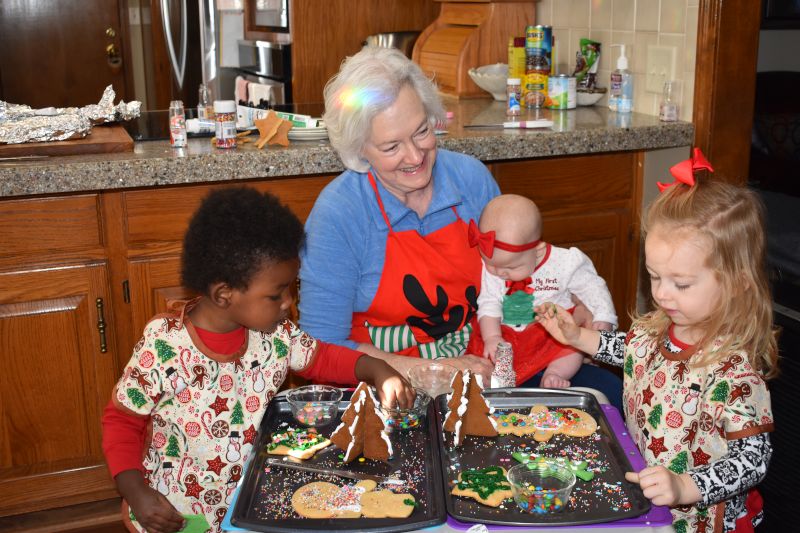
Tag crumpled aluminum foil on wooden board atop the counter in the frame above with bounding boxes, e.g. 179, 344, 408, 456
0, 85, 142, 144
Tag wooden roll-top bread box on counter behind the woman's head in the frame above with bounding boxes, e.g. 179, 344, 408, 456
412, 0, 536, 98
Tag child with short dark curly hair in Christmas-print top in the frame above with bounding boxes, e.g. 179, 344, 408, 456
103, 188, 413, 533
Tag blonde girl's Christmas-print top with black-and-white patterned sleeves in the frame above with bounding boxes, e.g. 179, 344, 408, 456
595, 323, 773, 533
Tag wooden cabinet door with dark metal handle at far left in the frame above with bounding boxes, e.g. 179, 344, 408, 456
0, 262, 117, 515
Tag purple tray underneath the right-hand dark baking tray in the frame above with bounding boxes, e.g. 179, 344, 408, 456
447, 404, 672, 531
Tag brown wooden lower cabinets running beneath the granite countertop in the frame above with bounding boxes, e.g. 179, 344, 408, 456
0, 153, 641, 529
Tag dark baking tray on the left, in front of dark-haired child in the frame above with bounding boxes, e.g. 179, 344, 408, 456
231, 391, 447, 532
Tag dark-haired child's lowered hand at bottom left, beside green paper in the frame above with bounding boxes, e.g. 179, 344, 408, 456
116, 470, 185, 533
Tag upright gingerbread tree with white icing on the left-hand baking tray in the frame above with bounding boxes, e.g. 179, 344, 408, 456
331, 382, 393, 463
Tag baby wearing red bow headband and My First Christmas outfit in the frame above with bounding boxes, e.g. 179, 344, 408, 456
467, 194, 617, 388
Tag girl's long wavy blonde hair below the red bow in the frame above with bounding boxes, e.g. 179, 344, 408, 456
639, 180, 778, 379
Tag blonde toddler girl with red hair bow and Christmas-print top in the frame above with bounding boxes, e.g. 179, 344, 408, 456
537, 154, 777, 532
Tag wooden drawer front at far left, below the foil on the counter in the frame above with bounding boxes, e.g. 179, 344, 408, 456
0, 194, 104, 259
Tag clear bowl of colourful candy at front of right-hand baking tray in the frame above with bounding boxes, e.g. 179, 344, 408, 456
506, 461, 575, 514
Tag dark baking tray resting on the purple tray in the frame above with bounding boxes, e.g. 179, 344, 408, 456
436, 389, 650, 526
